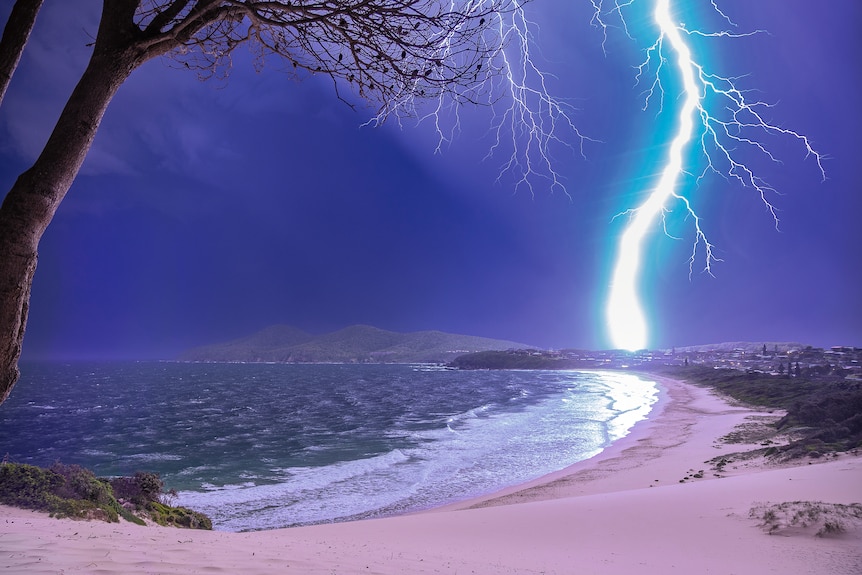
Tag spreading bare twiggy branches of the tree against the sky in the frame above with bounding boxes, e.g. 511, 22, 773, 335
127, 0, 518, 118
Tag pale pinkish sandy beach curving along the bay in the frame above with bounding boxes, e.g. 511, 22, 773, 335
0, 376, 862, 575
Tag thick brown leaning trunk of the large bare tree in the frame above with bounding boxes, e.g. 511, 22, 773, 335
0, 18, 144, 403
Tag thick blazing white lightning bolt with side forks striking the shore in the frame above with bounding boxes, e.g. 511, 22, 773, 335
604, 0, 826, 350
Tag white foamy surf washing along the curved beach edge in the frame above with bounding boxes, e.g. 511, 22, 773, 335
179, 372, 656, 530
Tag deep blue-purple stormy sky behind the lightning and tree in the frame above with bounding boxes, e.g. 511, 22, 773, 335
0, 0, 862, 358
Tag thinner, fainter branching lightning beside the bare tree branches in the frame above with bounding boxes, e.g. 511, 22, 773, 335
363, 0, 599, 196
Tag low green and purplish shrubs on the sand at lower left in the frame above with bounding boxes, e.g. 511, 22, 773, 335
0, 461, 212, 529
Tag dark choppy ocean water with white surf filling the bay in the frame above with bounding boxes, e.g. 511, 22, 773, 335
0, 362, 658, 531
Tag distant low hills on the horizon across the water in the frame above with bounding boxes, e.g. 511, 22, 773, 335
177, 325, 527, 363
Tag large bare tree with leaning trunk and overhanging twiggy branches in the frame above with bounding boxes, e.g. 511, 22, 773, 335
0, 0, 518, 402
